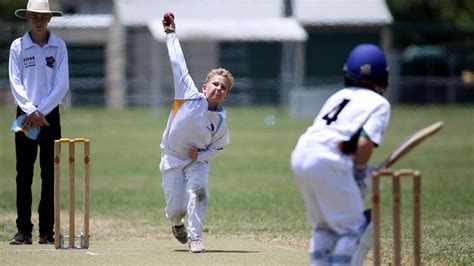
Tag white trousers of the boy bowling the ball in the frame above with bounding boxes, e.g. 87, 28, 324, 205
162, 161, 210, 239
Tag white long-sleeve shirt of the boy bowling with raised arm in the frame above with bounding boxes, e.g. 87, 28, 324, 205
160, 33, 230, 171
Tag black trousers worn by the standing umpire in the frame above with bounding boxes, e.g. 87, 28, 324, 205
15, 107, 61, 236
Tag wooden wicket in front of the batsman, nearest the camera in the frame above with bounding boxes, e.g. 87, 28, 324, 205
372, 169, 421, 265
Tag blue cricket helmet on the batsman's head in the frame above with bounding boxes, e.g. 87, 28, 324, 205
344, 43, 388, 87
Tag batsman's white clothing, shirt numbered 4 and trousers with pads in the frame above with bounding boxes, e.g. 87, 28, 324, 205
291, 88, 390, 265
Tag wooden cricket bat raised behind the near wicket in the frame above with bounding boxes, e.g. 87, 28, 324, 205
378, 121, 444, 169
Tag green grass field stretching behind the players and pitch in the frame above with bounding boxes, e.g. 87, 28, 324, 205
0, 106, 474, 264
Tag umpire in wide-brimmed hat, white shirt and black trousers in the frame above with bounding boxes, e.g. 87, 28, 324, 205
9, 0, 69, 244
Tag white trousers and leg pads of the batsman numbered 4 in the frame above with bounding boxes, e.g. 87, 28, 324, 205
291, 145, 365, 265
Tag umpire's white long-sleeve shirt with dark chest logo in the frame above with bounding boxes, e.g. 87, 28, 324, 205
9, 32, 69, 115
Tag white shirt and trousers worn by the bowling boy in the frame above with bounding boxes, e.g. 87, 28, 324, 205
160, 33, 229, 239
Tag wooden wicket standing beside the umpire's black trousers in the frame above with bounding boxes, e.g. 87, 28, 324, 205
54, 138, 90, 249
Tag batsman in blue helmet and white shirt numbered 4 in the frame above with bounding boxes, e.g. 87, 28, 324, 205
291, 44, 390, 265
